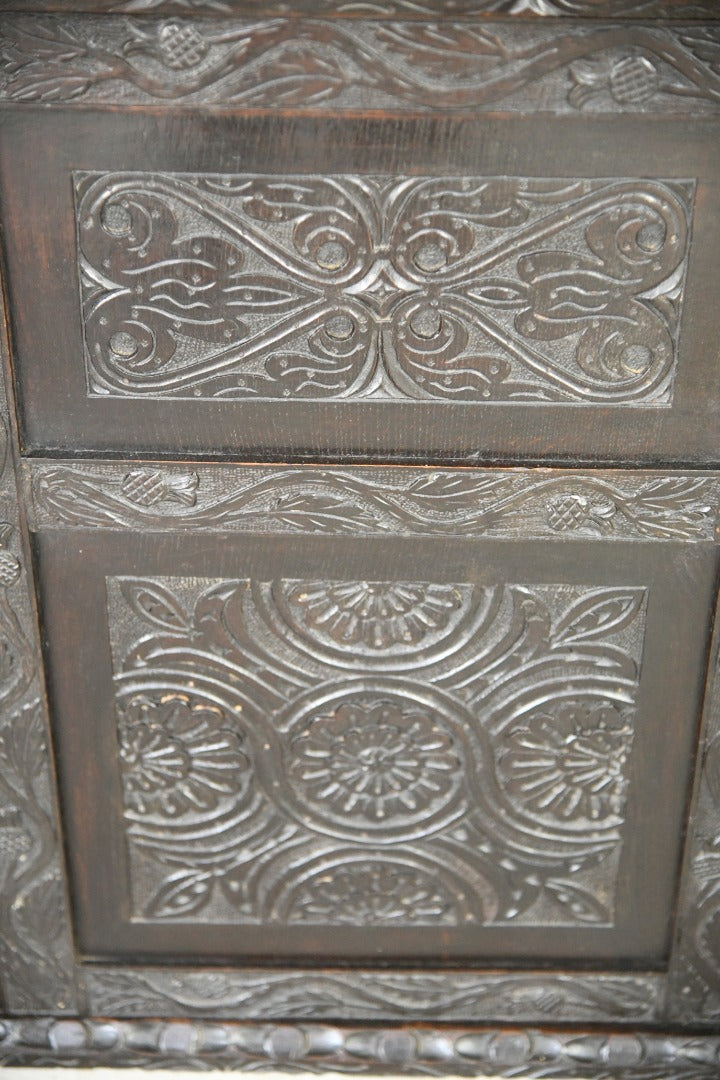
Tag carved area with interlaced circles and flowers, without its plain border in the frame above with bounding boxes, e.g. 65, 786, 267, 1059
108, 578, 646, 926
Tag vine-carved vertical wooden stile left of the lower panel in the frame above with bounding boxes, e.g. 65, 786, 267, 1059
0, 248, 78, 1014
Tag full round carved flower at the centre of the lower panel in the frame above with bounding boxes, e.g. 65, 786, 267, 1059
288, 701, 461, 822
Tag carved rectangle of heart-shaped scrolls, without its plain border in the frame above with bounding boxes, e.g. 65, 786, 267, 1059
76, 174, 692, 404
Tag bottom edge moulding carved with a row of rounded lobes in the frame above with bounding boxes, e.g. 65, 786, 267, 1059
0, 1020, 720, 1080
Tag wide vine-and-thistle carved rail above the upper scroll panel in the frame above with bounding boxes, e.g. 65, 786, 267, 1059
0, 16, 720, 114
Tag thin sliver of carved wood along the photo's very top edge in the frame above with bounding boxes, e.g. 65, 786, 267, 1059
4, 0, 719, 19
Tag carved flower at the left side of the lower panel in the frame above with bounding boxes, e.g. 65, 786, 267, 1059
118, 694, 249, 816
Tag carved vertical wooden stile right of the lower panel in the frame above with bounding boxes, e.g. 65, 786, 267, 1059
668, 574, 720, 1027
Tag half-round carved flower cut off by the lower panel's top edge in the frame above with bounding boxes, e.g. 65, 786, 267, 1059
288, 581, 462, 649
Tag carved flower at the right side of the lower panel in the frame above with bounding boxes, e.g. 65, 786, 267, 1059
500, 702, 633, 821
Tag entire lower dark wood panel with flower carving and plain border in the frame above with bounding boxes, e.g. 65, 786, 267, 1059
39, 529, 711, 963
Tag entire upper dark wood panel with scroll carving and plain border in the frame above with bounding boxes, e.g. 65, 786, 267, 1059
0, 111, 720, 463
